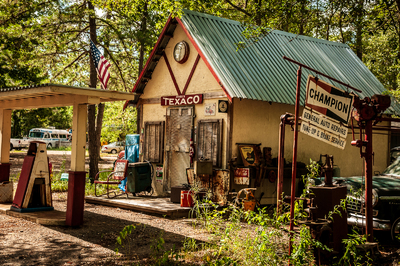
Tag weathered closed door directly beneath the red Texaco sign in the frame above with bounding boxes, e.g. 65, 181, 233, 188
164, 106, 193, 191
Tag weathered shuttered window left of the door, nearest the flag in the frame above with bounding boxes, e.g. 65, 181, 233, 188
143, 121, 164, 163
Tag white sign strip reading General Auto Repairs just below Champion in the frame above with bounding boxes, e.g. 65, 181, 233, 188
301, 109, 349, 138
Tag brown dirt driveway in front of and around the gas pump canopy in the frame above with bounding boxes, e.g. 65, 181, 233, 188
0, 152, 207, 266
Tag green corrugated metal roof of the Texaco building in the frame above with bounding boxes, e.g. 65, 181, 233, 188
181, 10, 400, 114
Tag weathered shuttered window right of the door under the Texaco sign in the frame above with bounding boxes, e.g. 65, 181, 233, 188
196, 119, 222, 167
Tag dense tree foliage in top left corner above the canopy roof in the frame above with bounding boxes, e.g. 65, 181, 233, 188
0, 0, 51, 87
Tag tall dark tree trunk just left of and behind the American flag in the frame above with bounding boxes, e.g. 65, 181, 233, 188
88, 2, 100, 183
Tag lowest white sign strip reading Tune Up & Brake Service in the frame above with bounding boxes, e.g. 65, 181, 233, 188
300, 121, 346, 150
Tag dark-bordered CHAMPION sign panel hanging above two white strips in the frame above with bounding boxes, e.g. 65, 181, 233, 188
306, 75, 353, 125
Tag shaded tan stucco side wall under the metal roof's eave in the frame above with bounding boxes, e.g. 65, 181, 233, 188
232, 99, 389, 176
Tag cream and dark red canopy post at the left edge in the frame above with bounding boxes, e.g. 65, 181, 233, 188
0, 109, 12, 182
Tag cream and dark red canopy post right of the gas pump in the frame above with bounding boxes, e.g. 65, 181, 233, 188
65, 104, 87, 226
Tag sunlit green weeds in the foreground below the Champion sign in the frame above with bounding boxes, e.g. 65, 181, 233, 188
186, 194, 327, 265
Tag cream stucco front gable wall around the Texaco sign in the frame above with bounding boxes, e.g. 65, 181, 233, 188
140, 25, 227, 194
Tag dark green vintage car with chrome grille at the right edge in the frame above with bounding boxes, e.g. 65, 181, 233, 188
335, 157, 400, 243
